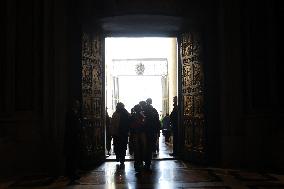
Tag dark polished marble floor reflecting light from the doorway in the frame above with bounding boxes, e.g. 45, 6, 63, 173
0, 135, 284, 189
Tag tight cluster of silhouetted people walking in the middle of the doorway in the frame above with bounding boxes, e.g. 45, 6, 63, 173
107, 98, 161, 172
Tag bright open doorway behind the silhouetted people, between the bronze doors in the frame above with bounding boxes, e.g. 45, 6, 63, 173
105, 37, 178, 161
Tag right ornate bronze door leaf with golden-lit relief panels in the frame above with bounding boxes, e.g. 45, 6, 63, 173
179, 32, 206, 163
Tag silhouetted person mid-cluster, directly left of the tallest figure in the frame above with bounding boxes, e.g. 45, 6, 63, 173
130, 104, 147, 172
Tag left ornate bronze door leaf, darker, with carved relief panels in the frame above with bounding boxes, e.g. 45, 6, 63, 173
81, 33, 105, 167
